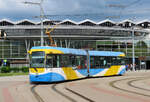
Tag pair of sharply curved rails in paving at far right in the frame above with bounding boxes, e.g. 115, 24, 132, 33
109, 77, 150, 97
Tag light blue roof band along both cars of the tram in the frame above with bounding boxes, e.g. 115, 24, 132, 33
31, 46, 125, 56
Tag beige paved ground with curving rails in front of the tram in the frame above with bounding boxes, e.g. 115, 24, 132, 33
0, 71, 150, 102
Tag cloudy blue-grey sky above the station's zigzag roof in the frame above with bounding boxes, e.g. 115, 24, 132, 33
0, 0, 150, 21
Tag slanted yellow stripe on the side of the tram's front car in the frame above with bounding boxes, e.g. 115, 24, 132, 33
62, 67, 78, 80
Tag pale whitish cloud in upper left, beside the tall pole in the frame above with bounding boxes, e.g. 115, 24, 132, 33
0, 0, 39, 18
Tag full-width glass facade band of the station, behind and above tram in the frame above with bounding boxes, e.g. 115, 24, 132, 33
0, 39, 150, 59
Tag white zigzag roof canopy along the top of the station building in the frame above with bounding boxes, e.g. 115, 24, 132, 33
0, 19, 150, 27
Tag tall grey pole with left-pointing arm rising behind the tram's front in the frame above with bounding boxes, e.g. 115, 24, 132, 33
24, 0, 44, 46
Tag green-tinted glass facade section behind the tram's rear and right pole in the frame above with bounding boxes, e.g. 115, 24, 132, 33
96, 40, 150, 57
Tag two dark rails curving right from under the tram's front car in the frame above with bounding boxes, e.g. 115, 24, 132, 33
52, 84, 95, 102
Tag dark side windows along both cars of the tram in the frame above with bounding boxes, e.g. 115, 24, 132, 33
44, 54, 125, 69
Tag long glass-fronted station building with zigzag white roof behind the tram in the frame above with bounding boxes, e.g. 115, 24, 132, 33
0, 19, 150, 69
